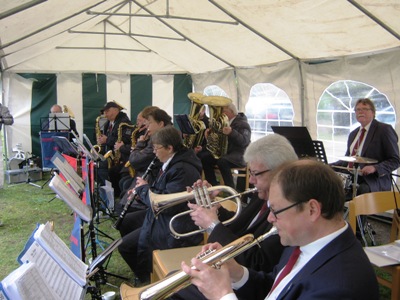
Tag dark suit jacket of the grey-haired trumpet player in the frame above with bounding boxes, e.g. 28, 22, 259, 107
208, 196, 283, 272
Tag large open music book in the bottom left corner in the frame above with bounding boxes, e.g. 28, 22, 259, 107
0, 223, 88, 299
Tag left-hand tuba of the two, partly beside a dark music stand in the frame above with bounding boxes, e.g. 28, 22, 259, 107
183, 93, 206, 149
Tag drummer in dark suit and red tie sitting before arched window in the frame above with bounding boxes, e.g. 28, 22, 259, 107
332, 98, 400, 194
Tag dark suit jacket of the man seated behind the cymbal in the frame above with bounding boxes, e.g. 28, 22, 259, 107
334, 120, 400, 192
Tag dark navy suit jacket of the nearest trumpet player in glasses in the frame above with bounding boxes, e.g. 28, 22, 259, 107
236, 226, 379, 300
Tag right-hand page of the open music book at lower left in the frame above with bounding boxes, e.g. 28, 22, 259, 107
34, 223, 88, 286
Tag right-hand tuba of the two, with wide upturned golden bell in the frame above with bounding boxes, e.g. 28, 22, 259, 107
202, 96, 232, 159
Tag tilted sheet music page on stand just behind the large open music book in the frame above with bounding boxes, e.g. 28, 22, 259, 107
49, 174, 92, 223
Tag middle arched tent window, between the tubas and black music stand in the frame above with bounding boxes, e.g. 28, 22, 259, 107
246, 83, 294, 141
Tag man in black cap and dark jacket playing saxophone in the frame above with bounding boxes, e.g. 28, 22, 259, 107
97, 101, 132, 196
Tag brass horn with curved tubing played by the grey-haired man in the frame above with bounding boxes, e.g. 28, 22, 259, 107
149, 185, 257, 238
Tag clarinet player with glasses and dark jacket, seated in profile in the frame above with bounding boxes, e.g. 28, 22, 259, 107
118, 125, 203, 282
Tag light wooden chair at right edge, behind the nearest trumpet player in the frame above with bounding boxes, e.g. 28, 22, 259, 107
349, 191, 400, 300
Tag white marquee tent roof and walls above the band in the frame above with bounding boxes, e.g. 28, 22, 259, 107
0, 0, 400, 164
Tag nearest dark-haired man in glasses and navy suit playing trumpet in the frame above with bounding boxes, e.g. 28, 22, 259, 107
182, 160, 379, 300
